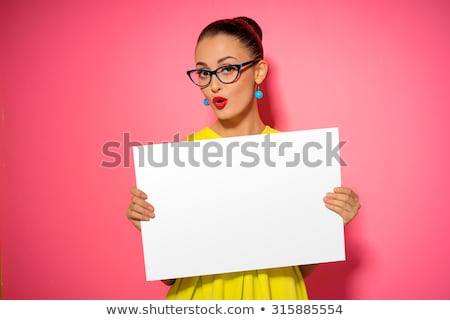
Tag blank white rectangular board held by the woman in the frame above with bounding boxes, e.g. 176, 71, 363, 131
133, 128, 345, 281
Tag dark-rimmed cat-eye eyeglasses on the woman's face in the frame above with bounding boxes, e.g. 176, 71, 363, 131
187, 58, 261, 87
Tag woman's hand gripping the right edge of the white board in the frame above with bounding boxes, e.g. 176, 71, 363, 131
323, 187, 361, 225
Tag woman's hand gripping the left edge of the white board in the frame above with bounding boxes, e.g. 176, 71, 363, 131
127, 187, 155, 230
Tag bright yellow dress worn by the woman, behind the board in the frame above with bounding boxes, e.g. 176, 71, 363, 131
166, 126, 308, 300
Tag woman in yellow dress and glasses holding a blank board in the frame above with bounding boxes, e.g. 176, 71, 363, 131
127, 17, 360, 300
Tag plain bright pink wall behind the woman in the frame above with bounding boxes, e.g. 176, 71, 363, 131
0, 0, 450, 299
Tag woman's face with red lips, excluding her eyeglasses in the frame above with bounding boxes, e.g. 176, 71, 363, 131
195, 34, 256, 120
